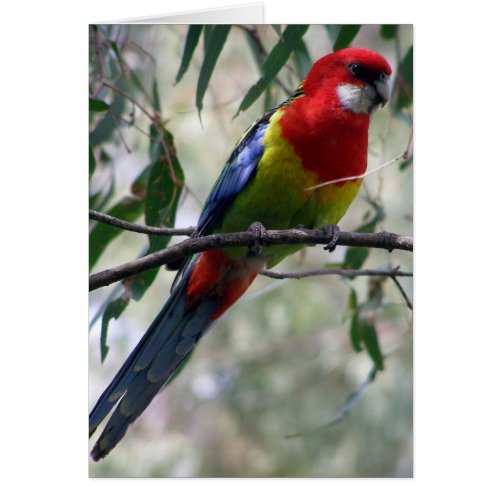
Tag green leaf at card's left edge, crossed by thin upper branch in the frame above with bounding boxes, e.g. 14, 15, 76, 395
89, 196, 144, 269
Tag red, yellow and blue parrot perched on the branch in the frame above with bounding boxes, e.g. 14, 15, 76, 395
89, 48, 392, 461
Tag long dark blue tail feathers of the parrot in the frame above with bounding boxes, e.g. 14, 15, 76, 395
89, 268, 217, 460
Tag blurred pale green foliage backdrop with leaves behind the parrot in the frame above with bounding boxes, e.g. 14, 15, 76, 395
89, 25, 413, 477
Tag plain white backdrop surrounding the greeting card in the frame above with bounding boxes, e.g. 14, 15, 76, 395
0, 0, 500, 499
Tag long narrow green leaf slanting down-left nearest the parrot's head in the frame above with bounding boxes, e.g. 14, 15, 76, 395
236, 24, 309, 115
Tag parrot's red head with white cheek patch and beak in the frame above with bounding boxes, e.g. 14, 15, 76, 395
303, 48, 392, 113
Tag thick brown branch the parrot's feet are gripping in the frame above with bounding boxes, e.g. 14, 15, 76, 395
89, 228, 413, 291
